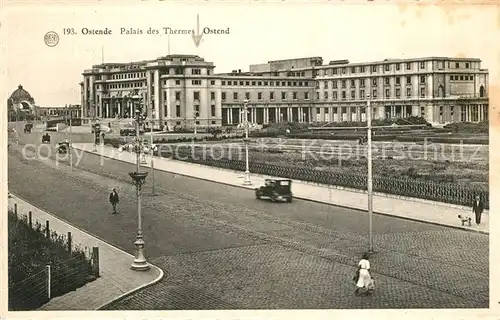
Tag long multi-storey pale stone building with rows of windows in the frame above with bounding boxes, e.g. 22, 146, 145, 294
81, 55, 488, 128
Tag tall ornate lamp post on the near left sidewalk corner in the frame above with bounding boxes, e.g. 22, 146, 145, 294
129, 94, 150, 271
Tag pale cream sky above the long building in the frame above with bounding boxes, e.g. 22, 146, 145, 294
0, 2, 500, 106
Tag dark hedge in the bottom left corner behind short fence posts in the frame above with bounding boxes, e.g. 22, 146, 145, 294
8, 210, 97, 311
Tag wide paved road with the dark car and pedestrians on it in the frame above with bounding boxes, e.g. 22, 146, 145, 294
9, 147, 489, 310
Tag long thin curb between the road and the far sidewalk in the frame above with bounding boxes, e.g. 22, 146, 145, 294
75, 147, 489, 235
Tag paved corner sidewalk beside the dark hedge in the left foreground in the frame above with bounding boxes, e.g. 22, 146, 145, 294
9, 194, 163, 311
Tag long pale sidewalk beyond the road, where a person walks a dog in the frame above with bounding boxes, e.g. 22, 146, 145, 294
73, 143, 489, 234
